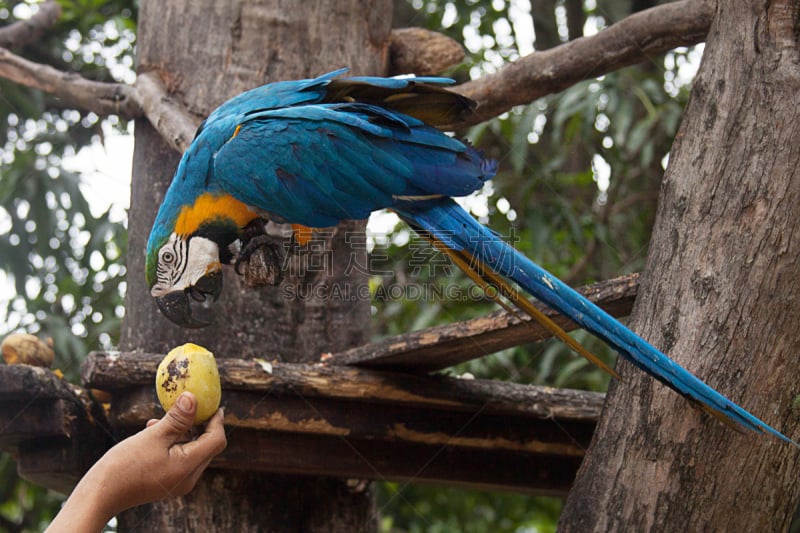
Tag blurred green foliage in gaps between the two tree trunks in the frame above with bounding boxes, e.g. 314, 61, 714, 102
372, 0, 696, 532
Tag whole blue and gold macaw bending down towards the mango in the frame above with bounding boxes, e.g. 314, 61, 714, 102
146, 69, 794, 443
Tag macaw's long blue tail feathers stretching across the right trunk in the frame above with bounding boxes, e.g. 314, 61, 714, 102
394, 198, 800, 447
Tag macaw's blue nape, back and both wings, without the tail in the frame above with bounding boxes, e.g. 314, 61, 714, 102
147, 69, 482, 251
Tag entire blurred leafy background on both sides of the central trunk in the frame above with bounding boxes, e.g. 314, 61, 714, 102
0, 0, 702, 532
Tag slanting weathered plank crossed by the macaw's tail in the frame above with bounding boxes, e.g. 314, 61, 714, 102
325, 273, 639, 372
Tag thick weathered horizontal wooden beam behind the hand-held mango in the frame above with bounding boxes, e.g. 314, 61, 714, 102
83, 353, 603, 494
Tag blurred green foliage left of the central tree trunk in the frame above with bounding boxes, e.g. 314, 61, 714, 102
0, 0, 135, 531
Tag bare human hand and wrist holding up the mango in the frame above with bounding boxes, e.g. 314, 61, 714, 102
47, 392, 227, 532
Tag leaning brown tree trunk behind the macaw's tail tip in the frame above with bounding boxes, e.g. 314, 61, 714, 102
560, 0, 800, 532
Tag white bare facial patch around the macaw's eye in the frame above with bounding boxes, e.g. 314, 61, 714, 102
150, 233, 222, 297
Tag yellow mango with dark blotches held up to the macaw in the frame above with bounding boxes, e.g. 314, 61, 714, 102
156, 343, 222, 425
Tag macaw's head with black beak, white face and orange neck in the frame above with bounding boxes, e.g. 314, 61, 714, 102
145, 192, 257, 328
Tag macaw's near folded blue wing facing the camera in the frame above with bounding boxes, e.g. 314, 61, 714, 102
208, 103, 495, 227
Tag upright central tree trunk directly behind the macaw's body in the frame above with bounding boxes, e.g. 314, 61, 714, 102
119, 0, 392, 532
